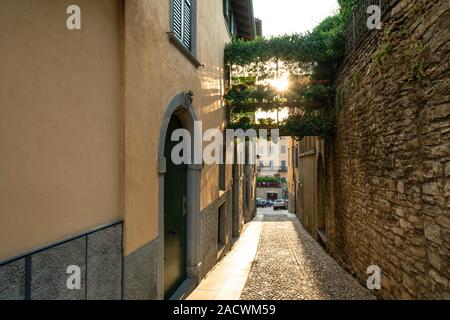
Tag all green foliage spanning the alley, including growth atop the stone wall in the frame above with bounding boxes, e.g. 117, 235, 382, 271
225, 0, 359, 138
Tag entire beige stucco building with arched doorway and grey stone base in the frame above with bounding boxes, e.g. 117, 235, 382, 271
0, 0, 255, 299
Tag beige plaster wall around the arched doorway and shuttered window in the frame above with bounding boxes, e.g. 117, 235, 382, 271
125, 0, 231, 254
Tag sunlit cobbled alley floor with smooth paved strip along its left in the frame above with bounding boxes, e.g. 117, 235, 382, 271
189, 208, 373, 300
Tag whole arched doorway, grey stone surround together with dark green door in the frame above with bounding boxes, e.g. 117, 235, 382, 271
157, 92, 203, 299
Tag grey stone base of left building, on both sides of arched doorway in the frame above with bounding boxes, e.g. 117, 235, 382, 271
0, 186, 254, 300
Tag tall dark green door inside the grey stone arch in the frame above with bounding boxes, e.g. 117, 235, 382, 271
164, 116, 187, 298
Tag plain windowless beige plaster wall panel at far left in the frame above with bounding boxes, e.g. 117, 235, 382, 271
0, 0, 123, 260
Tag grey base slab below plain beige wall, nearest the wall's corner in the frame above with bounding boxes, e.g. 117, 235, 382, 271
86, 225, 122, 300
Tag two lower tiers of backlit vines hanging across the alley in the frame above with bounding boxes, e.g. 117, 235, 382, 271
225, 80, 335, 138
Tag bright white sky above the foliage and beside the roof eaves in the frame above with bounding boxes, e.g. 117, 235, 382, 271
253, 0, 339, 36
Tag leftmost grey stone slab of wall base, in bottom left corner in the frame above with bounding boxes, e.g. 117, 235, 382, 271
0, 259, 25, 300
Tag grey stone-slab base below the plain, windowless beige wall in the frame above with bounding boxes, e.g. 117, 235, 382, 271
0, 223, 123, 300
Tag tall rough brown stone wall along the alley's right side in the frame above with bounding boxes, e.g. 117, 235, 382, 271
327, 0, 450, 299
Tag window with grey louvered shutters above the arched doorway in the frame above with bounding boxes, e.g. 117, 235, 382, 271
172, 0, 193, 51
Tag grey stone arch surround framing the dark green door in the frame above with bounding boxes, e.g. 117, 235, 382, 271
157, 92, 202, 299
